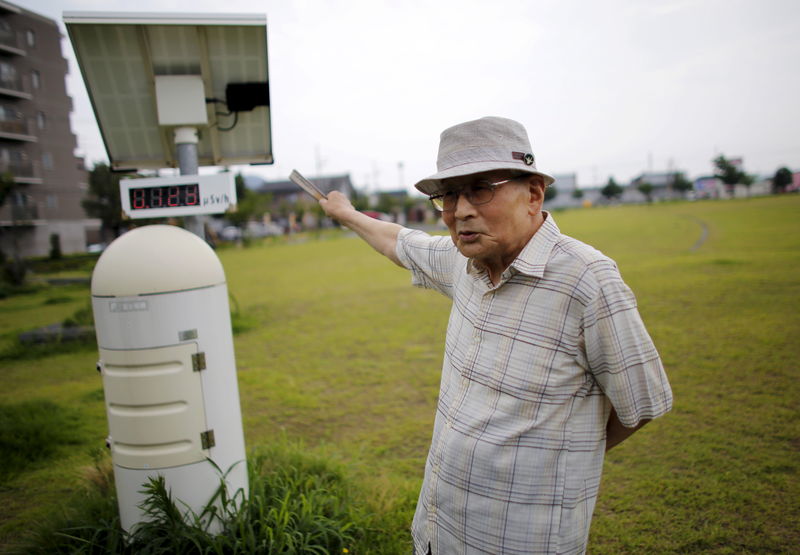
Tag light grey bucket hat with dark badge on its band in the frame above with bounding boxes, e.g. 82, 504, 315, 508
414, 116, 555, 195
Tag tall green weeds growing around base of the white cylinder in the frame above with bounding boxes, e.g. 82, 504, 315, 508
12, 446, 374, 555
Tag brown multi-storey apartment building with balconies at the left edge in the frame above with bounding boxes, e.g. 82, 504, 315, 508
0, 0, 92, 257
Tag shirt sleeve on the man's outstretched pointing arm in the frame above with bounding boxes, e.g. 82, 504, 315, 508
395, 229, 466, 299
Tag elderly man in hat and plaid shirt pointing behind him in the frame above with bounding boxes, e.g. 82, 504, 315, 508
320, 117, 672, 555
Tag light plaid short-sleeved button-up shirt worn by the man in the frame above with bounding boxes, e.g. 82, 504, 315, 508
397, 214, 672, 555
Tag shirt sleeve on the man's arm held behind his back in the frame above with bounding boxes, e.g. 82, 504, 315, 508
584, 260, 672, 428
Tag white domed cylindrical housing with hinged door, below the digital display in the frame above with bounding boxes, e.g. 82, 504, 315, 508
92, 225, 248, 530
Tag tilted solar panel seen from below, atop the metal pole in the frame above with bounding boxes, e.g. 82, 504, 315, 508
64, 12, 273, 169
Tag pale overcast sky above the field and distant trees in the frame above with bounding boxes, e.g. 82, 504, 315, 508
23, 0, 800, 190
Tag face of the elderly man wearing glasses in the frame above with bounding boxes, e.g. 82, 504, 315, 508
442, 171, 544, 273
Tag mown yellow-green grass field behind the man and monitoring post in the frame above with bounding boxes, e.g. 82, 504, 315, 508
0, 196, 800, 554
